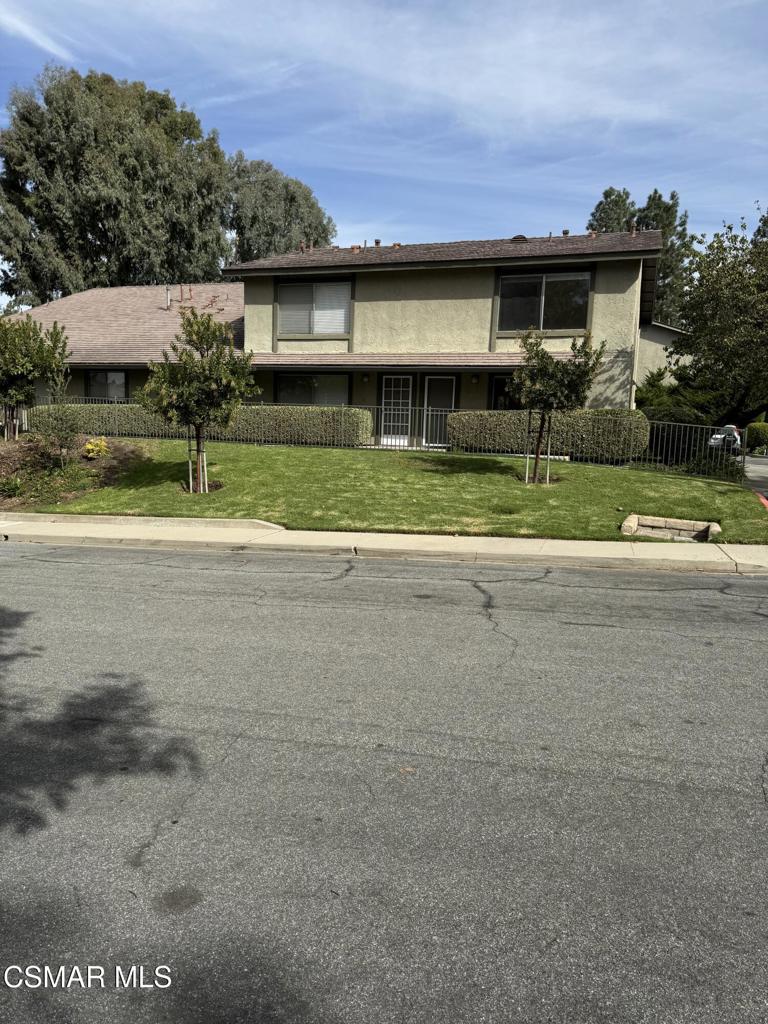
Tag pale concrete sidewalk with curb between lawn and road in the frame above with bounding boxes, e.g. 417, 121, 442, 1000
0, 512, 768, 573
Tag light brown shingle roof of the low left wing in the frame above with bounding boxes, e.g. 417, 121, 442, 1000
14, 281, 243, 367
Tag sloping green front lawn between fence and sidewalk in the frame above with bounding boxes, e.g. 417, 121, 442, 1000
30, 441, 768, 544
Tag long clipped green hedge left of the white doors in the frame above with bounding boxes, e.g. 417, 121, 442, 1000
29, 402, 374, 447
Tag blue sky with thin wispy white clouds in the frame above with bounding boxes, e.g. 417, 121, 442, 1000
0, 0, 768, 245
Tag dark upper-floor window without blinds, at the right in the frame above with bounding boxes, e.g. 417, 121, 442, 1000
499, 273, 590, 331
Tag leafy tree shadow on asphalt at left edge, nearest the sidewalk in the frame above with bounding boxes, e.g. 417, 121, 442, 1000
0, 607, 200, 835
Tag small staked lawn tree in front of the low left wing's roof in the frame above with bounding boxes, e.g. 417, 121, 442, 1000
138, 308, 261, 494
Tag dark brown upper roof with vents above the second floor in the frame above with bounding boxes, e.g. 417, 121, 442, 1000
224, 231, 662, 276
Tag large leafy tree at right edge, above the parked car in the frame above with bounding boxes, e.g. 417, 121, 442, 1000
673, 221, 768, 425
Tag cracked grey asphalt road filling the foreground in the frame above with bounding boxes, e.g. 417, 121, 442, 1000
0, 544, 768, 1024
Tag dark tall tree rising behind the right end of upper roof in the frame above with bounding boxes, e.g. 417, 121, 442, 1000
587, 186, 700, 327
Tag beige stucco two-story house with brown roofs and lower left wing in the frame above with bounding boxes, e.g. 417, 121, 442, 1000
19, 231, 675, 439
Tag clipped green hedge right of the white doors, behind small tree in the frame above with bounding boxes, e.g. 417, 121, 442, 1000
447, 409, 649, 462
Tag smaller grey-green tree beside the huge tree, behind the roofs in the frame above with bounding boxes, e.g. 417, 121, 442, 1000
227, 151, 336, 262
